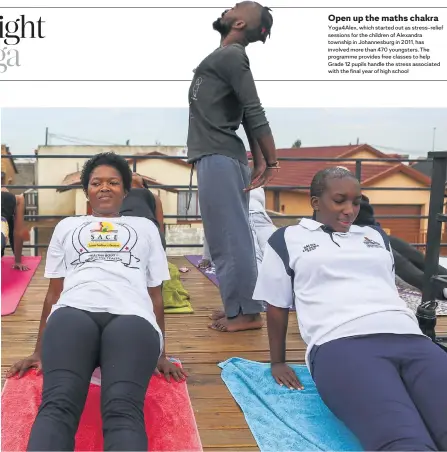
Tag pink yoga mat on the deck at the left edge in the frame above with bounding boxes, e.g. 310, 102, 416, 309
2, 256, 42, 315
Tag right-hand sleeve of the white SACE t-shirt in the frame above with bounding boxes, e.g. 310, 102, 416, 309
146, 220, 171, 287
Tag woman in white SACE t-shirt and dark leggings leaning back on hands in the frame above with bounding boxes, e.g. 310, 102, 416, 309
7, 153, 186, 451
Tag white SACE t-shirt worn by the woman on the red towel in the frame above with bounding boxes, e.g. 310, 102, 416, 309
45, 216, 170, 350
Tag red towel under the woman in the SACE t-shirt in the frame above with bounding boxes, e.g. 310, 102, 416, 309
1, 370, 203, 451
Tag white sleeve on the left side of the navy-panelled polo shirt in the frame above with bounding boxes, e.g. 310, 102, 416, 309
253, 243, 294, 309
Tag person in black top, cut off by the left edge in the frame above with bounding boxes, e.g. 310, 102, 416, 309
1, 171, 29, 271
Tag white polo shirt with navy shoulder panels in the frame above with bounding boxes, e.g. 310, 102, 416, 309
253, 219, 422, 365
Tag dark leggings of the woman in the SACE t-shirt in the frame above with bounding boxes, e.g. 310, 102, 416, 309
27, 307, 160, 451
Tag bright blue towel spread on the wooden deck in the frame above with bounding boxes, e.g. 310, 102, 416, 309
219, 358, 363, 452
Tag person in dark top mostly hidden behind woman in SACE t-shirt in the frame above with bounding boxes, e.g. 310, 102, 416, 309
120, 173, 166, 249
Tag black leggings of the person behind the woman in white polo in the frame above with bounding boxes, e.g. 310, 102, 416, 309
390, 235, 447, 300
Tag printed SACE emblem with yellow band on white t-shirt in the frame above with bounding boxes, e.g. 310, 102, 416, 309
71, 221, 140, 268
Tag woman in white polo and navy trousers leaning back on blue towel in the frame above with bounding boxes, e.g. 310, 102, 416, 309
253, 168, 447, 451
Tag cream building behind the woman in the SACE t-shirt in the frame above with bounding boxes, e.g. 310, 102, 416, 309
36, 145, 203, 254
